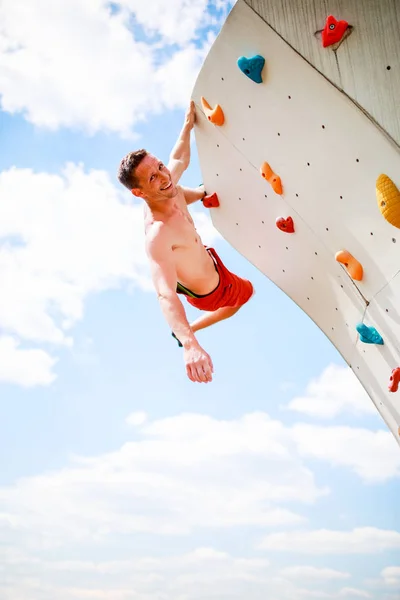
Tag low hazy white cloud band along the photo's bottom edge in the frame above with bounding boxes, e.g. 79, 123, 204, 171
0, 547, 376, 600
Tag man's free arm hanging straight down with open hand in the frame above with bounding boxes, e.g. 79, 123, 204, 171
146, 227, 213, 382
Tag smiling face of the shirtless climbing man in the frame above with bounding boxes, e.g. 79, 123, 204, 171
132, 154, 177, 202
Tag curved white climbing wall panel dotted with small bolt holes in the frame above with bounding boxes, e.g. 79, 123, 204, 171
193, 0, 400, 442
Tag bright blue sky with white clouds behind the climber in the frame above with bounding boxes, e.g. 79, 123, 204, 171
0, 0, 400, 600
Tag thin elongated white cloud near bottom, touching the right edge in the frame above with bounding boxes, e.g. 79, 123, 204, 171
260, 527, 400, 555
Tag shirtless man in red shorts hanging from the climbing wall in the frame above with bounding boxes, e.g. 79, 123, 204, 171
118, 102, 254, 383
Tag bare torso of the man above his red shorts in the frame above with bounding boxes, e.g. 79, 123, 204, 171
144, 186, 219, 295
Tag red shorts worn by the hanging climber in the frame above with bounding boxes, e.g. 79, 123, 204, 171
181, 248, 254, 311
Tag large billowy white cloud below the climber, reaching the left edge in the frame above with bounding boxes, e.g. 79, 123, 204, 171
0, 413, 326, 547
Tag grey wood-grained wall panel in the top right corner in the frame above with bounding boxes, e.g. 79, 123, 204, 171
246, 0, 400, 146
